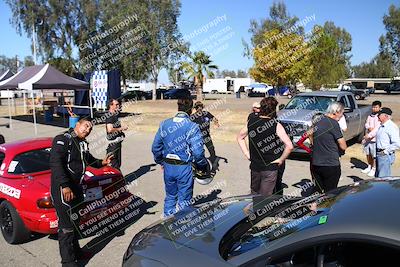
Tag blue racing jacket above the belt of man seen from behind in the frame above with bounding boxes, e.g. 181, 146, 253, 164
152, 112, 207, 166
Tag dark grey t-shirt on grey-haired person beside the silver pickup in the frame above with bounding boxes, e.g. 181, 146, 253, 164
312, 116, 343, 166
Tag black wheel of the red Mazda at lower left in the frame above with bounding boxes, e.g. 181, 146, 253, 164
0, 201, 30, 244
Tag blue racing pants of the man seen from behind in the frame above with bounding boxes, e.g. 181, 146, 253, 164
163, 163, 193, 216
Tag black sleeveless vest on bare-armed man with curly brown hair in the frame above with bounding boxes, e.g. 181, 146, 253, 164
247, 116, 284, 171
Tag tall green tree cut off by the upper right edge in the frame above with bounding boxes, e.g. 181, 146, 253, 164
380, 5, 400, 75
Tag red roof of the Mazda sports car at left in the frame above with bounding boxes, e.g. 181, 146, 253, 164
0, 137, 53, 154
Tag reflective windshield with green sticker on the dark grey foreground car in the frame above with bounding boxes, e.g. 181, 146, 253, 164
222, 189, 344, 259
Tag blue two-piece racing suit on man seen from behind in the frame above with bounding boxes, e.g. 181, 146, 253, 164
152, 112, 207, 216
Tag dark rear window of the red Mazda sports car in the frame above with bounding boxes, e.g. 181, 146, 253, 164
8, 148, 51, 174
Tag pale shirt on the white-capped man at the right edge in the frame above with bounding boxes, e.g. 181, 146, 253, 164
376, 120, 400, 154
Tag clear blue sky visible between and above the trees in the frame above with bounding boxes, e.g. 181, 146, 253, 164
0, 0, 399, 82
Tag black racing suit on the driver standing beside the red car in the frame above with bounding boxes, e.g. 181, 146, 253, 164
50, 129, 102, 266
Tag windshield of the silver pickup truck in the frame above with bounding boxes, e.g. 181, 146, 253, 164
285, 96, 335, 112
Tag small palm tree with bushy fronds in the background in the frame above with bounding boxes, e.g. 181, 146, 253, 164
182, 51, 218, 100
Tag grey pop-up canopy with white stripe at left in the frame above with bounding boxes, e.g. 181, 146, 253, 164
0, 64, 92, 134
